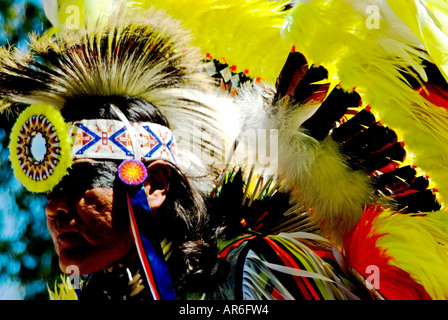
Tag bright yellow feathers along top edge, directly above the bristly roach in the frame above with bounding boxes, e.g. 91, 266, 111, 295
46, 0, 291, 82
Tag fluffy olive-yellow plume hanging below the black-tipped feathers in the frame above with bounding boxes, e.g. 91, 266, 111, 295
279, 130, 374, 243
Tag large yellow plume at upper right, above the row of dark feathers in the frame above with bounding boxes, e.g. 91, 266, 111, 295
283, 0, 448, 208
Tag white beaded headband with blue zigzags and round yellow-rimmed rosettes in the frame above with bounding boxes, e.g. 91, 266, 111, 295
10, 104, 176, 192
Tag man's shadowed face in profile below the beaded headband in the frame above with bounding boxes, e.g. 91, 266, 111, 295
45, 162, 134, 274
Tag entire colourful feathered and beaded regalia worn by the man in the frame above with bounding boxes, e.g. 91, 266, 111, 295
0, 0, 448, 300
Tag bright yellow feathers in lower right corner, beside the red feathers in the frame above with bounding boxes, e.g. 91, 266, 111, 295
375, 211, 448, 300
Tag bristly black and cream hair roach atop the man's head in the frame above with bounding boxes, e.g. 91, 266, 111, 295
0, 5, 243, 190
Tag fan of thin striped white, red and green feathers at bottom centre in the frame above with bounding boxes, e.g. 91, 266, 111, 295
234, 232, 358, 300
